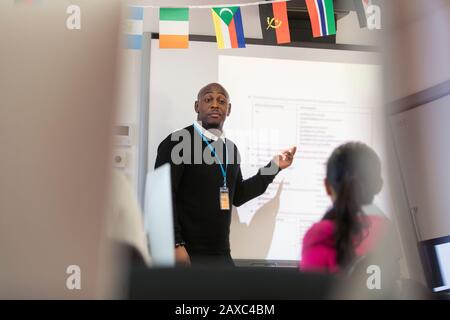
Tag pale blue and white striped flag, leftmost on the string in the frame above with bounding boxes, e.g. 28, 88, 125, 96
125, 7, 144, 50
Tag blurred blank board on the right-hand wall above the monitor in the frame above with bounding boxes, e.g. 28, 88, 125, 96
390, 95, 450, 241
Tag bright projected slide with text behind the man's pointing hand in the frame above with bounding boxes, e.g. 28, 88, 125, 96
219, 56, 382, 260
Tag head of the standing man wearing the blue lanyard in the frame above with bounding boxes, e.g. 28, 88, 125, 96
195, 85, 231, 129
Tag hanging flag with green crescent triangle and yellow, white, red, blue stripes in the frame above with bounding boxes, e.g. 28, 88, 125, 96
211, 7, 245, 49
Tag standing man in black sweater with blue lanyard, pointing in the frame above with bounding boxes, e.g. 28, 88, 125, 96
155, 83, 296, 266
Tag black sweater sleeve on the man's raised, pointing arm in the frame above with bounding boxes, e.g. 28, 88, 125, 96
233, 161, 280, 207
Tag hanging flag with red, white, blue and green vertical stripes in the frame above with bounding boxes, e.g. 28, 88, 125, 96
306, 0, 336, 38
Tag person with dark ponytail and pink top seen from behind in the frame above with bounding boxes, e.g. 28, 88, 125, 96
300, 142, 387, 273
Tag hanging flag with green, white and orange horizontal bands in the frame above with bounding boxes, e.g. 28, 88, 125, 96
159, 8, 189, 49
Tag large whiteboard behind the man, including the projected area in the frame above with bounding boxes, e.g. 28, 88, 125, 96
148, 40, 384, 260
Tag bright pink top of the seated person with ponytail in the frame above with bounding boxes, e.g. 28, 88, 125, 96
299, 215, 387, 272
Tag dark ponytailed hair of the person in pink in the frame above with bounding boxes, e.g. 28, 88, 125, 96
324, 142, 382, 267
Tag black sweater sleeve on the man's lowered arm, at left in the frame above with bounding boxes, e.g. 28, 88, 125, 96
155, 136, 184, 243
